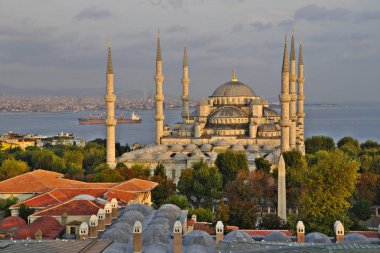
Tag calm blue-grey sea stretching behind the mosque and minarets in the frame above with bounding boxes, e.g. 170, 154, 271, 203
0, 104, 380, 145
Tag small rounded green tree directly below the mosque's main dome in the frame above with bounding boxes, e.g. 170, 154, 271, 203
215, 149, 249, 185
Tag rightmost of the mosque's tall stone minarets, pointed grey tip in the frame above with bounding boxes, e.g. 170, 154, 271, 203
297, 43, 305, 154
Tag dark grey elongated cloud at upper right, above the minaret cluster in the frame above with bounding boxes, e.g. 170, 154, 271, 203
294, 4, 352, 21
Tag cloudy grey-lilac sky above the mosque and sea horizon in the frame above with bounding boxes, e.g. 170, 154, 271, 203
0, 0, 380, 103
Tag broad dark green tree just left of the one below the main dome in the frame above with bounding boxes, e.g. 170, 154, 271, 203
177, 161, 223, 207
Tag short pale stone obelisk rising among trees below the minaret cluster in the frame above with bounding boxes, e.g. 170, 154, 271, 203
277, 154, 286, 222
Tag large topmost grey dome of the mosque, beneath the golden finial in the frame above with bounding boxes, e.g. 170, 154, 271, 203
211, 81, 257, 97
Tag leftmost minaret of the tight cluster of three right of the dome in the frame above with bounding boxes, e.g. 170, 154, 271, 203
280, 36, 290, 152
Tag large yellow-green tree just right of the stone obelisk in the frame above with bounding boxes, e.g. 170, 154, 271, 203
300, 150, 359, 235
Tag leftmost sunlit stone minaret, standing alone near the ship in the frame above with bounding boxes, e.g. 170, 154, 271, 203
104, 42, 116, 168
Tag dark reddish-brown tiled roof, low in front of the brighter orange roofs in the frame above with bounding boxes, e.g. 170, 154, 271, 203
32, 199, 104, 216
